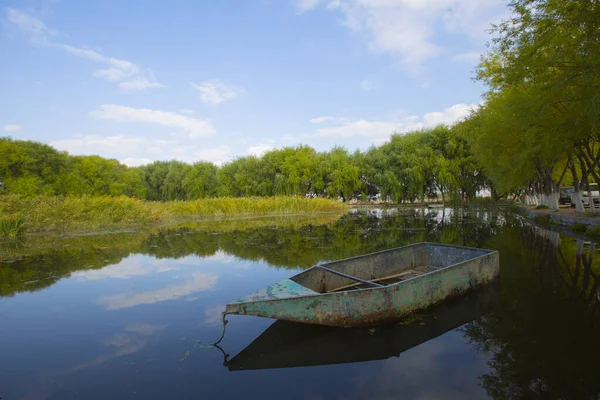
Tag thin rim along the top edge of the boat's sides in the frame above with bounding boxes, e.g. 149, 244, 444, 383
227, 242, 498, 306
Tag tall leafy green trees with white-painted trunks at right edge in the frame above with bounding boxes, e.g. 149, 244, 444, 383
456, 0, 600, 212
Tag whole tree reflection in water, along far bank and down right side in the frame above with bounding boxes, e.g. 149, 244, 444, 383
0, 209, 600, 399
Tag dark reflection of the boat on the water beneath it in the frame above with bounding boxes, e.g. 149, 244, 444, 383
224, 284, 499, 371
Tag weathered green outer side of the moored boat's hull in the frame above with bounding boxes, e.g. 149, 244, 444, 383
226, 244, 499, 327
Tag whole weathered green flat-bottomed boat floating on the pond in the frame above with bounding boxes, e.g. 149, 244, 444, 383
225, 243, 499, 327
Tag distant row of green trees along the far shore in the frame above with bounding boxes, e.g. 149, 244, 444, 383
0, 125, 489, 202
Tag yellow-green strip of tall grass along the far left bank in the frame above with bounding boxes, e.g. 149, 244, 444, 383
0, 195, 347, 236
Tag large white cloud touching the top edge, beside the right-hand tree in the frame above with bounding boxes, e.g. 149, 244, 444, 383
294, 0, 507, 73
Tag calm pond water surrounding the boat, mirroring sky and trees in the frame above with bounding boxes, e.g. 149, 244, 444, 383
0, 209, 600, 400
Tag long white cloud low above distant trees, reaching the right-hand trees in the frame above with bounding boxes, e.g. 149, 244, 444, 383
311, 104, 478, 145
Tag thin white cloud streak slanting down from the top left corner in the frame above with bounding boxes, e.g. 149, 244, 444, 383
6, 8, 163, 90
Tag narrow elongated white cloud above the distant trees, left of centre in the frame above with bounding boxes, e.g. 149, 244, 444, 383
91, 104, 215, 138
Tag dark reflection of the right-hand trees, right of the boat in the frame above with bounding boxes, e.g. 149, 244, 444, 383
461, 224, 600, 399
